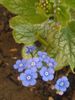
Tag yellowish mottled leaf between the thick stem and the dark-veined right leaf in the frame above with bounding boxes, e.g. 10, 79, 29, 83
39, 22, 68, 71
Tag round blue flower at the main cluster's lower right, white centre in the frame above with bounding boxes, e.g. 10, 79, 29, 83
40, 67, 54, 81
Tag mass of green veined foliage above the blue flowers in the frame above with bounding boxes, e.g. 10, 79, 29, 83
0, 0, 75, 71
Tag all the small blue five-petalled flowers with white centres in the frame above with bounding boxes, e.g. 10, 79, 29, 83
13, 46, 69, 92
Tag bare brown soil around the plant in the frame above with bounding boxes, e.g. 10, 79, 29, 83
0, 5, 75, 100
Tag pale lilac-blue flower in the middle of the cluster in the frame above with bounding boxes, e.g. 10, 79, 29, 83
26, 58, 42, 70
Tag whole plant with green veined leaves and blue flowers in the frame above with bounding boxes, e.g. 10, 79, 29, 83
0, 0, 75, 92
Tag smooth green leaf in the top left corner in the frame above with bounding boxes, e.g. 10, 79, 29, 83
0, 0, 47, 24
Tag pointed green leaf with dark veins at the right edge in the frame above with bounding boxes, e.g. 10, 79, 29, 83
58, 21, 75, 71
